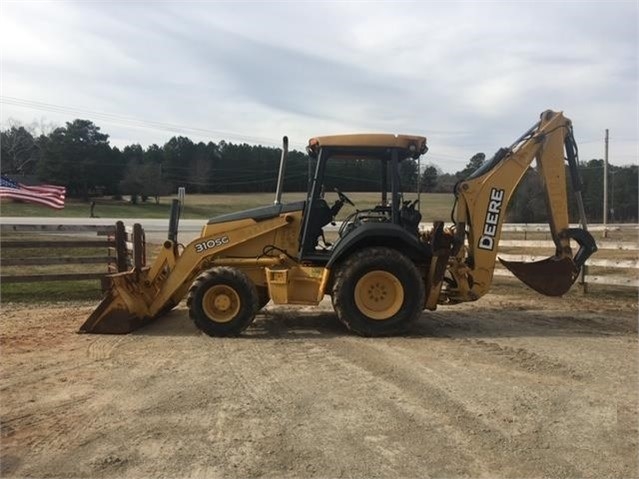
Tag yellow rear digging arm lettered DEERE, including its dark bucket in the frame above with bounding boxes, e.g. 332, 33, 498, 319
443, 111, 597, 302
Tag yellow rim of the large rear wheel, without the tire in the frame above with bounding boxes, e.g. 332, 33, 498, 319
355, 270, 404, 321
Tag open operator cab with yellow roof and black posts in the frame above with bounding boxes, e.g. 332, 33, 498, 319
299, 134, 428, 264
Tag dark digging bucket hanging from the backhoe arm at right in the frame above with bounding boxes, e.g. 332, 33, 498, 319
499, 256, 579, 296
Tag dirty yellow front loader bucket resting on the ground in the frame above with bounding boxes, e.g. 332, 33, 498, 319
79, 271, 152, 334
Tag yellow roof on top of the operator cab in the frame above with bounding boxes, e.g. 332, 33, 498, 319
306, 133, 428, 159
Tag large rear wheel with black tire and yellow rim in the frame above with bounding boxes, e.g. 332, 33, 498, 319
332, 247, 425, 336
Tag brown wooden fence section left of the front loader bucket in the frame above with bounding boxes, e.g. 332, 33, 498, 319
0, 221, 146, 283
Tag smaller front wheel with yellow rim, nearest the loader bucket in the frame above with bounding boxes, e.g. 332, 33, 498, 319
186, 267, 258, 336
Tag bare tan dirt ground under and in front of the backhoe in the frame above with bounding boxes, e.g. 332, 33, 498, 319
0, 286, 639, 478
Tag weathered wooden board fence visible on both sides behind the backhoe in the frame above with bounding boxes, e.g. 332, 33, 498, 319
0, 221, 639, 290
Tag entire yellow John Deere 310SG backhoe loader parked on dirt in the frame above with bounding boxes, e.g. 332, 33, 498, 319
80, 111, 597, 336
